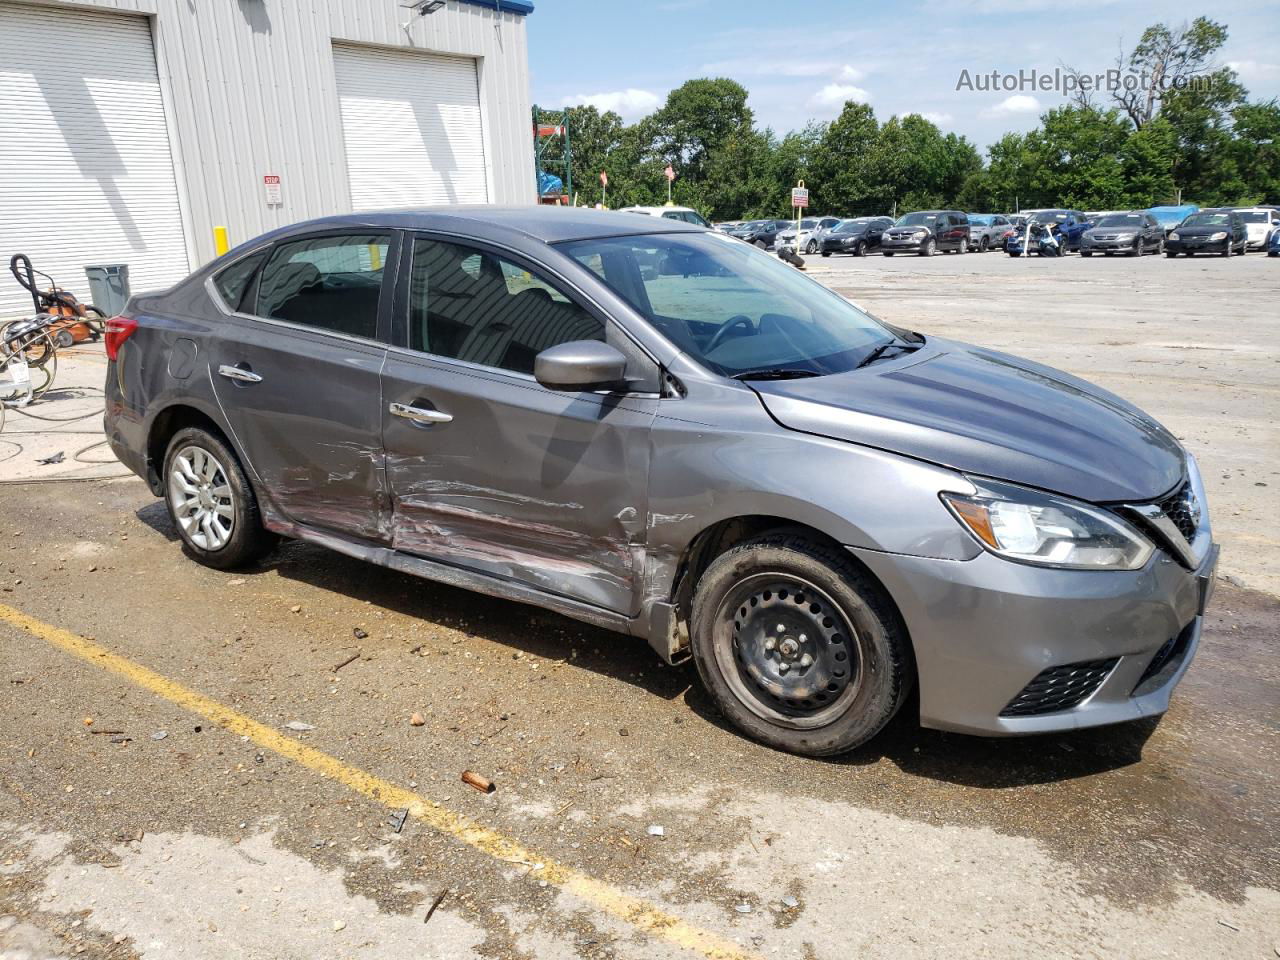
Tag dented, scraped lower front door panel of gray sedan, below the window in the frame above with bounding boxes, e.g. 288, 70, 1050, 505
383, 349, 658, 614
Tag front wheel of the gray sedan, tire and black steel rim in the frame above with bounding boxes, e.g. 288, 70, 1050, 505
690, 534, 914, 756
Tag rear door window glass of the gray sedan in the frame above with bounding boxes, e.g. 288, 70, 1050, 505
256, 233, 389, 339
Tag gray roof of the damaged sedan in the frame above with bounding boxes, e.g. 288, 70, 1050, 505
238, 204, 705, 244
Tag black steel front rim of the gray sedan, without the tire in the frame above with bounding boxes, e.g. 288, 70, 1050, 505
714, 573, 861, 730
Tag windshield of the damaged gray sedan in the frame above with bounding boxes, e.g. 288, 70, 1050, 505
557, 233, 896, 376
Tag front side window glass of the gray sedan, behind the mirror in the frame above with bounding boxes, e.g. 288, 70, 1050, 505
408, 237, 605, 374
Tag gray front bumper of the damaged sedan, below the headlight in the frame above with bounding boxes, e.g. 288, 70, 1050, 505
850, 545, 1217, 736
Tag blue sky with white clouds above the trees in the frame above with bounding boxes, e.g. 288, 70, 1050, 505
529, 0, 1280, 148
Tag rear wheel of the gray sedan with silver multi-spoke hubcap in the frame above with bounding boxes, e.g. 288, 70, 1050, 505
163, 426, 276, 570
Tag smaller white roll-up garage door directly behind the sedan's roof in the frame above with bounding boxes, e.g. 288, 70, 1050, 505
333, 44, 489, 210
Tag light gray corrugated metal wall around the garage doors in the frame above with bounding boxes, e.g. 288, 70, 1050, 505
10, 0, 536, 266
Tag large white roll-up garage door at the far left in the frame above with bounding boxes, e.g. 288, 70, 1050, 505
0, 3, 188, 316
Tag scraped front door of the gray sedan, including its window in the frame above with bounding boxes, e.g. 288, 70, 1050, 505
383, 236, 657, 614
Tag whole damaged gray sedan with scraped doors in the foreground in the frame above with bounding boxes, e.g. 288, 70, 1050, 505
106, 207, 1217, 755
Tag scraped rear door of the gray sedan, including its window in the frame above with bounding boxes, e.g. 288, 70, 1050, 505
209, 229, 398, 540
